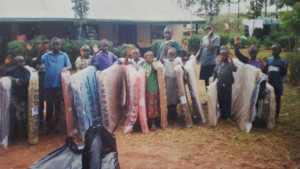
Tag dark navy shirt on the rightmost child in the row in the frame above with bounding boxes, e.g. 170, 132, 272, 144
265, 57, 286, 95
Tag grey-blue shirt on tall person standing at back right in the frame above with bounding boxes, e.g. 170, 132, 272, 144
200, 35, 221, 66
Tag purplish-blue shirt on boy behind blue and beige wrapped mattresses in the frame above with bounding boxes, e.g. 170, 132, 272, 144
91, 51, 122, 71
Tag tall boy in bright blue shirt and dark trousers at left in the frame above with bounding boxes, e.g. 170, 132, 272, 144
41, 37, 72, 132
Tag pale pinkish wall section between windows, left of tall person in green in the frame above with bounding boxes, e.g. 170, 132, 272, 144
137, 25, 151, 48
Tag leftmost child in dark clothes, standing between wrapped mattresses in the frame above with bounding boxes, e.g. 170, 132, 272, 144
2, 55, 30, 138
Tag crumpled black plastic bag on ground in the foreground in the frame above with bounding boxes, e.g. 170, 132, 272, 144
30, 126, 120, 169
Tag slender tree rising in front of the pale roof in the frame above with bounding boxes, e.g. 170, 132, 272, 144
71, 0, 89, 40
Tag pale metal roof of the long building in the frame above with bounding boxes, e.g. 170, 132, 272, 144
0, 0, 205, 24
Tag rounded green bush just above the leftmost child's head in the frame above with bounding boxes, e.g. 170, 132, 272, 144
7, 40, 27, 57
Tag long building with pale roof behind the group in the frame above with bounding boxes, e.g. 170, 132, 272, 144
0, 0, 205, 57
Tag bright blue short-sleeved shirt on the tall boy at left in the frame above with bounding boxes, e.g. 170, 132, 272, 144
41, 51, 71, 88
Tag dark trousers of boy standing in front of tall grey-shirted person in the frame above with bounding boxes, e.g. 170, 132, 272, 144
218, 84, 232, 119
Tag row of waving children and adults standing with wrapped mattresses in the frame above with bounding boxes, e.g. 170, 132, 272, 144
2, 24, 288, 137
